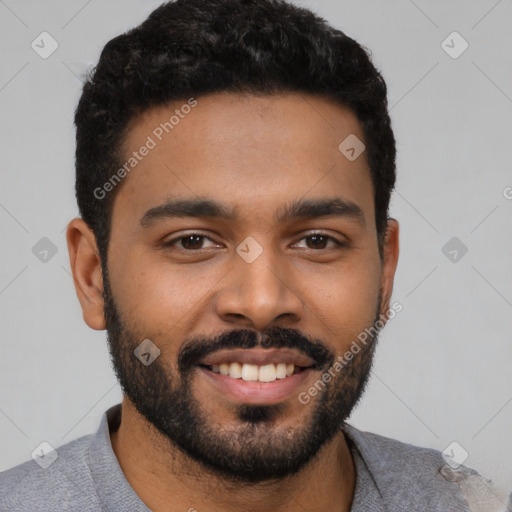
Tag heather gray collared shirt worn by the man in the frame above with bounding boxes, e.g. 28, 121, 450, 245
0, 404, 505, 512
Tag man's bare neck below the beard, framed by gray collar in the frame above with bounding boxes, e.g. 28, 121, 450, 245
110, 398, 356, 512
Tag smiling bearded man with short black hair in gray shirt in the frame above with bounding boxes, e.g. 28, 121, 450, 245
0, 0, 505, 512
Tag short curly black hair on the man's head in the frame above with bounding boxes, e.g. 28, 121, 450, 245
75, 0, 396, 262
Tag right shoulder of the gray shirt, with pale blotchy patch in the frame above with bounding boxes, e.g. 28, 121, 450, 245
343, 424, 511, 512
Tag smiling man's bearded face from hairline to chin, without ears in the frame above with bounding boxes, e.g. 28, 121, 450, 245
102, 93, 392, 482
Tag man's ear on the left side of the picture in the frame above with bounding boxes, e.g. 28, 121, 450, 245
66, 218, 106, 331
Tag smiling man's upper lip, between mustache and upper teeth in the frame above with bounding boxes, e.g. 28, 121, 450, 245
199, 348, 315, 368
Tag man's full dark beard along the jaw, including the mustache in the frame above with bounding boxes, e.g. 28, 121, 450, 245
103, 262, 381, 484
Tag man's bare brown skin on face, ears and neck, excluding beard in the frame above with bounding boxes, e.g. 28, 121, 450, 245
67, 93, 398, 512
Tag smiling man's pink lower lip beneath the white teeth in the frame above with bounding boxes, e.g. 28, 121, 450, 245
198, 366, 313, 405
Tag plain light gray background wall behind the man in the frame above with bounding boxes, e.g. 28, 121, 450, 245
0, 0, 512, 496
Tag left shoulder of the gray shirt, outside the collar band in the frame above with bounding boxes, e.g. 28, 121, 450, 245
0, 435, 100, 512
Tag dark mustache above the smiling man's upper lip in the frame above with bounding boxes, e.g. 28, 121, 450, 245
178, 327, 335, 374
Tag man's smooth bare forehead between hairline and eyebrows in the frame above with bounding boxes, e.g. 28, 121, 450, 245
113, 93, 373, 229
